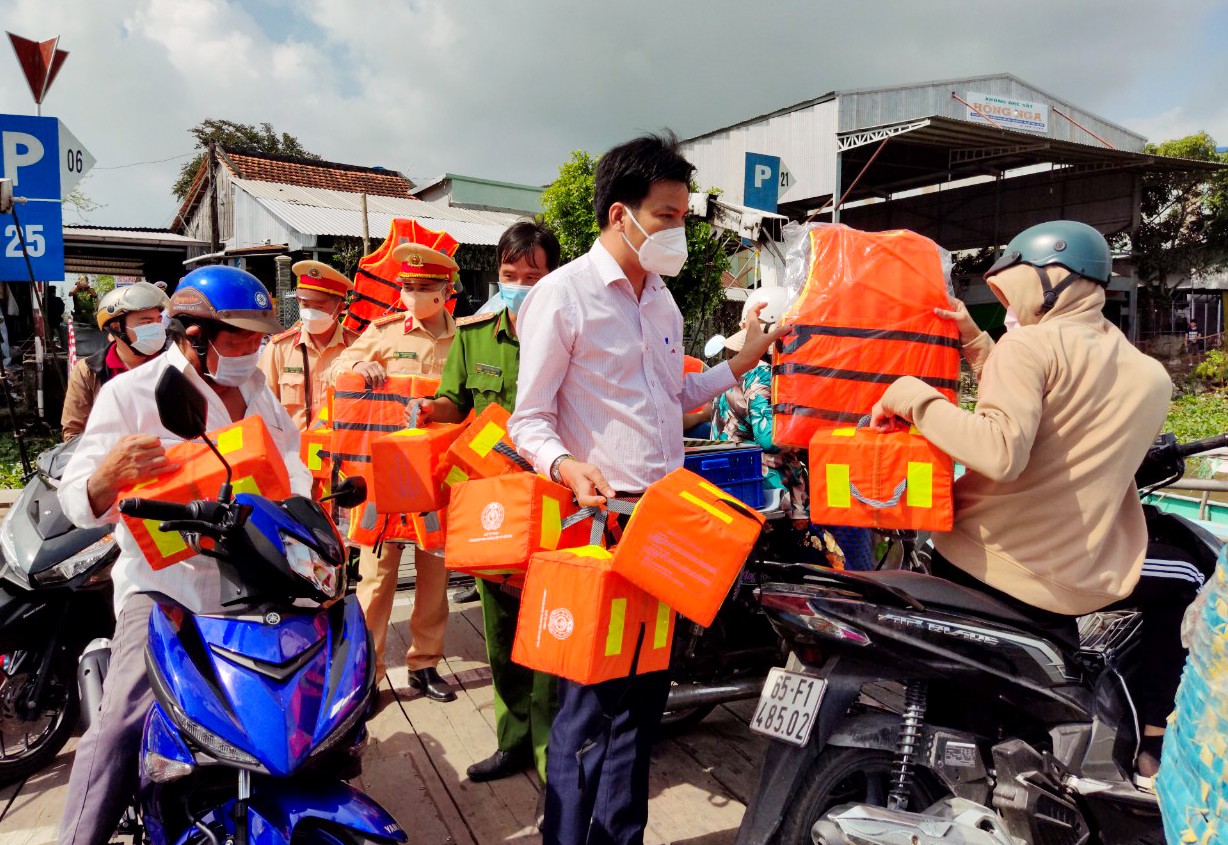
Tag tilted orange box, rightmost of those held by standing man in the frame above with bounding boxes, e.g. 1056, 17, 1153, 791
613, 469, 764, 626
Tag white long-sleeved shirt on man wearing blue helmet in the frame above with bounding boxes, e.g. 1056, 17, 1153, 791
59, 344, 311, 617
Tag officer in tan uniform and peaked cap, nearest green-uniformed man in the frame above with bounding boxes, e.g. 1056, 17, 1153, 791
332, 243, 457, 701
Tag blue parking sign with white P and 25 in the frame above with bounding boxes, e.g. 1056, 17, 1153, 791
0, 114, 64, 281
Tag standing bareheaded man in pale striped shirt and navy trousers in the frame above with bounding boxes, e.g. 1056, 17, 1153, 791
510, 135, 786, 845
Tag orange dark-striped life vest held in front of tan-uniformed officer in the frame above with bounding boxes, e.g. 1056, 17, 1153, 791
333, 372, 440, 491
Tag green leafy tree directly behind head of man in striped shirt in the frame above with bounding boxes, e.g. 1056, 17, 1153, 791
542, 150, 729, 346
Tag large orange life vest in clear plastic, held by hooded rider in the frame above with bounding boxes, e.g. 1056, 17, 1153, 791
772, 225, 959, 448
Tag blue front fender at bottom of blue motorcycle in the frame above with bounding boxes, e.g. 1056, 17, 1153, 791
178, 779, 408, 845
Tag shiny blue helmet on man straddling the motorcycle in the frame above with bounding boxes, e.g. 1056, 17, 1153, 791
168, 264, 281, 334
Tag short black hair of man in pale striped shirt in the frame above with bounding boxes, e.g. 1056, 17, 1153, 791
593, 130, 695, 230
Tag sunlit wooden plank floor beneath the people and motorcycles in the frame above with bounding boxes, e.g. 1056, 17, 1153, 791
0, 591, 763, 845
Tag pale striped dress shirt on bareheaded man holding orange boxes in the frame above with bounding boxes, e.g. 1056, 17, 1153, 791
510, 241, 736, 493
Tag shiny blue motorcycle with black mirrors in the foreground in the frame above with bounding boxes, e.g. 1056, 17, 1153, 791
119, 370, 406, 845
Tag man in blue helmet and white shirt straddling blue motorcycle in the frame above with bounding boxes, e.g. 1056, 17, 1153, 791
59, 267, 311, 845
